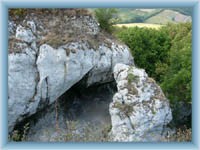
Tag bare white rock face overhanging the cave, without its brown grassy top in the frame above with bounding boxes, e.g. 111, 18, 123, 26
8, 21, 133, 131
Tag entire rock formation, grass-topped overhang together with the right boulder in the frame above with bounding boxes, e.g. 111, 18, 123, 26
8, 9, 171, 141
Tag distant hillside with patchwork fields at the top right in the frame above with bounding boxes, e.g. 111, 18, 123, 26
115, 8, 192, 24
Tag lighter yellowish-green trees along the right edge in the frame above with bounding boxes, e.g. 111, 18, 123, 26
161, 23, 192, 103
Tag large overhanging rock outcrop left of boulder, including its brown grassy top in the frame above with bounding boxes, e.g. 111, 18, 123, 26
8, 10, 133, 132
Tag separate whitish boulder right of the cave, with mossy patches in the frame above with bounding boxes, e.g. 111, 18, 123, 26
109, 64, 172, 141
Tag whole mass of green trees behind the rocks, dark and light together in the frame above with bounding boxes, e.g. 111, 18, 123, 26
115, 23, 192, 127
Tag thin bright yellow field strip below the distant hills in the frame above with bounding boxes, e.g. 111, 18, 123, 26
115, 23, 162, 29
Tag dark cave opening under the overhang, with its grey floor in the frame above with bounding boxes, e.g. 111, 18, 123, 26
14, 79, 117, 142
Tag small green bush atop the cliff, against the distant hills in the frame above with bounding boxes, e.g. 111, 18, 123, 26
95, 8, 117, 32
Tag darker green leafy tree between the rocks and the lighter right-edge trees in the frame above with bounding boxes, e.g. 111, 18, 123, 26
116, 27, 170, 82
